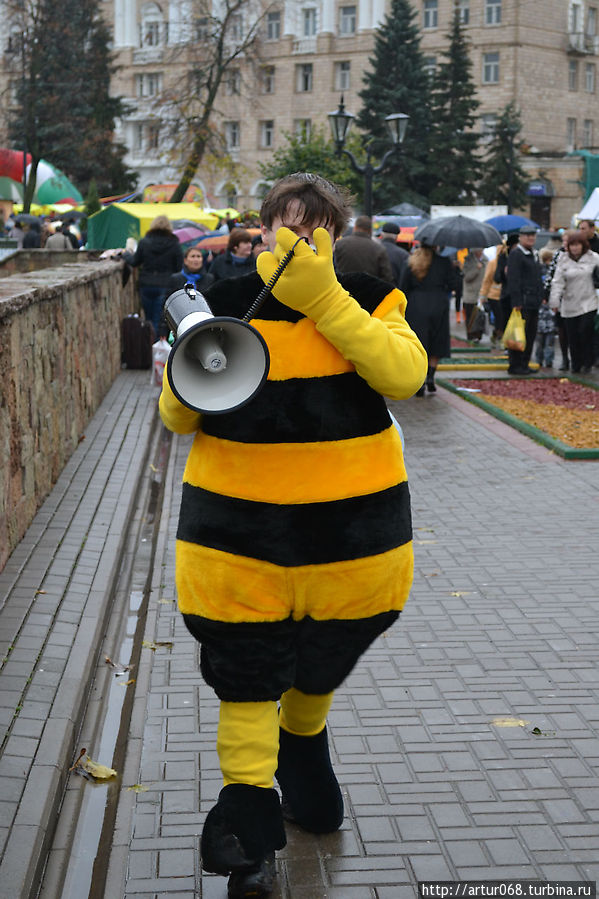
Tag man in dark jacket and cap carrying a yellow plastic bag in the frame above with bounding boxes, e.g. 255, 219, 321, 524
507, 225, 543, 375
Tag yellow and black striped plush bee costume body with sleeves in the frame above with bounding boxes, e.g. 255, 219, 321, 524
160, 274, 427, 702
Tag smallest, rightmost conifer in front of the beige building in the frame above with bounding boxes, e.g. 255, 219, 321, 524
478, 101, 529, 212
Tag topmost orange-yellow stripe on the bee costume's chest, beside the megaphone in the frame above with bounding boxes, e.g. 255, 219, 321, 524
251, 318, 354, 381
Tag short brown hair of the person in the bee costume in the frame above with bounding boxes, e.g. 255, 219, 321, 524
260, 172, 352, 237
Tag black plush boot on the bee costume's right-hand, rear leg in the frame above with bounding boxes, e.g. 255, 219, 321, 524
275, 727, 343, 833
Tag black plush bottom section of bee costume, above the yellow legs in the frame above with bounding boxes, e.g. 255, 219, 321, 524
184, 612, 399, 702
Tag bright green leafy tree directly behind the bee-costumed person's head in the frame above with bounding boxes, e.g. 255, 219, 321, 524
260, 128, 362, 194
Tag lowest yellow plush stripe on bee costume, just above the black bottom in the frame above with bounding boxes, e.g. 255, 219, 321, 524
177, 540, 413, 622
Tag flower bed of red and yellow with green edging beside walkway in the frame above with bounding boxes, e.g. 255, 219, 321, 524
439, 378, 599, 459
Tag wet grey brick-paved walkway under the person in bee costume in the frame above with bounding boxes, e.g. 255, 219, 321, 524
0, 366, 599, 899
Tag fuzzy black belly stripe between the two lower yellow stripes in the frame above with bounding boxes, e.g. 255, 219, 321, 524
177, 482, 412, 566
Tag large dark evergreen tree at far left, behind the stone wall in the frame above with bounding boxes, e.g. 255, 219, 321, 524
5, 0, 135, 211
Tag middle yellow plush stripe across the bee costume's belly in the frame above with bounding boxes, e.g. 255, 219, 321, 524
183, 425, 407, 504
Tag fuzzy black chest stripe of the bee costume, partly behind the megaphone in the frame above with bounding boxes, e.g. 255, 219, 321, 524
202, 372, 390, 443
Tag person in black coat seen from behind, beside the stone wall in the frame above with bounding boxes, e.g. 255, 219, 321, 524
123, 215, 183, 333
